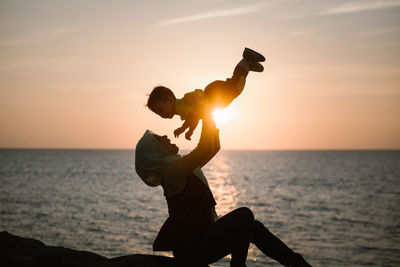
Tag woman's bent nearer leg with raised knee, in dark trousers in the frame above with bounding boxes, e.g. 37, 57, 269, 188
174, 208, 254, 267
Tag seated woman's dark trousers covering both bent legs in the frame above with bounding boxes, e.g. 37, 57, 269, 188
174, 208, 299, 266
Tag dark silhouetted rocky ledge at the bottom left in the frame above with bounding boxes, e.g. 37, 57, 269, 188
0, 232, 209, 267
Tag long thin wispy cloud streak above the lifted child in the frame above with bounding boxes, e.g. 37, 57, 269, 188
156, 4, 264, 27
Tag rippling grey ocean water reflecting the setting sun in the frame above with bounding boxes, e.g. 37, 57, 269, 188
0, 150, 400, 266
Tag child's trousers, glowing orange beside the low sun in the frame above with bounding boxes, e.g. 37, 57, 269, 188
204, 65, 248, 108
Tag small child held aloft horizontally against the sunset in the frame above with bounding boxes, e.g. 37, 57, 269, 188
147, 48, 265, 140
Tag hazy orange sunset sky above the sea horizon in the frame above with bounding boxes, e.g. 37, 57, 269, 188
0, 0, 400, 150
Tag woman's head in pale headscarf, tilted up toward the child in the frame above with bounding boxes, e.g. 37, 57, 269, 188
135, 130, 180, 186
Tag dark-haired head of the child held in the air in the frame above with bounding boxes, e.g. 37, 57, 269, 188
147, 86, 176, 119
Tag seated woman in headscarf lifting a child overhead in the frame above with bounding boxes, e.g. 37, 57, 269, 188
135, 113, 310, 266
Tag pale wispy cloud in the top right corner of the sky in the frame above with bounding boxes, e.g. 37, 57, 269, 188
318, 0, 400, 15
